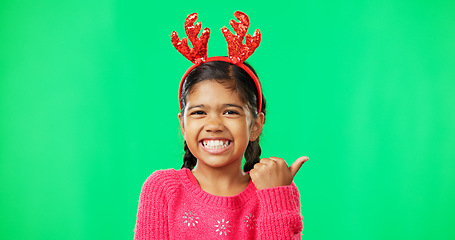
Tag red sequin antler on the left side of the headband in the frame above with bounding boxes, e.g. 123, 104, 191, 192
171, 13, 210, 63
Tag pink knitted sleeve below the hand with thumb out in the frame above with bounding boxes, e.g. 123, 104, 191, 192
257, 183, 303, 239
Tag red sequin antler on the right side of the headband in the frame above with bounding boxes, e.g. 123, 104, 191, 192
222, 11, 261, 63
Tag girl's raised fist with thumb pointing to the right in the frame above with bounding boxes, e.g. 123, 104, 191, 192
250, 156, 308, 190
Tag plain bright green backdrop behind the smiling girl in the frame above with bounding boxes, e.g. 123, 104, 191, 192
0, 0, 455, 240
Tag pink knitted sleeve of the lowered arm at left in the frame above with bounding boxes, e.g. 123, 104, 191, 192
134, 170, 175, 240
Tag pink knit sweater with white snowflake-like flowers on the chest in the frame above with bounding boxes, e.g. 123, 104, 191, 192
134, 168, 303, 240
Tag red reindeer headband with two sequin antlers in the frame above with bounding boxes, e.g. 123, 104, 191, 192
171, 11, 262, 112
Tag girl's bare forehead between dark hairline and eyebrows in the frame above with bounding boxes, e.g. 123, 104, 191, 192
188, 80, 243, 104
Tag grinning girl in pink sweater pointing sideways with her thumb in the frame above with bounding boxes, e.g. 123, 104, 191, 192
135, 13, 308, 239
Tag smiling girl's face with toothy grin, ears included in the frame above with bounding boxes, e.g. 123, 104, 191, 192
179, 80, 263, 171
